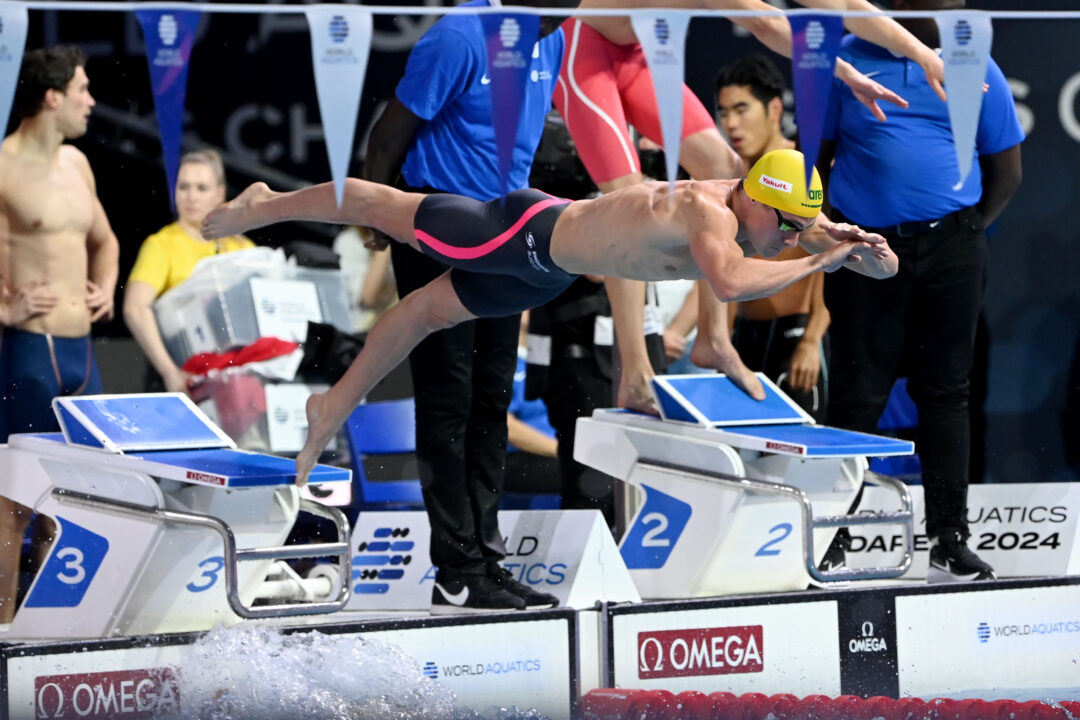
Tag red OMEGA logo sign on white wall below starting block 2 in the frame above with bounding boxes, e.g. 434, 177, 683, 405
637, 625, 765, 680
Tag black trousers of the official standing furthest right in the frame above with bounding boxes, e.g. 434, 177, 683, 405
825, 209, 986, 538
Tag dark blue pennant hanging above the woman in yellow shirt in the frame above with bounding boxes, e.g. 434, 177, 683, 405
135, 9, 202, 212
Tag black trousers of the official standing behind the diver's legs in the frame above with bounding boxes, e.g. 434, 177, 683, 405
391, 193, 521, 580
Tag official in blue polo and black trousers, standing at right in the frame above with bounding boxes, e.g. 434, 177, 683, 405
818, 0, 1024, 582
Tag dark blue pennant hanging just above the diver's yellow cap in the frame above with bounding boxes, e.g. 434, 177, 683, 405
787, 13, 843, 188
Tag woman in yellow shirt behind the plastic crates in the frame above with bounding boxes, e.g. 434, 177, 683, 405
124, 150, 255, 392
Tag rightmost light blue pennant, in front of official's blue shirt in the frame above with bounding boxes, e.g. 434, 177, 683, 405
934, 12, 994, 190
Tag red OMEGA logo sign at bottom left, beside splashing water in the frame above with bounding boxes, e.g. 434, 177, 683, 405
33, 667, 180, 720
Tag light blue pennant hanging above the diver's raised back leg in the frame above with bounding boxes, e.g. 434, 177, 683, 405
303, 5, 372, 207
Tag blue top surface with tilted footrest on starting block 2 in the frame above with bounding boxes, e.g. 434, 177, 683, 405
652, 372, 915, 458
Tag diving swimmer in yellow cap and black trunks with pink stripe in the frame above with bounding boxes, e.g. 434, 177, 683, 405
203, 150, 896, 485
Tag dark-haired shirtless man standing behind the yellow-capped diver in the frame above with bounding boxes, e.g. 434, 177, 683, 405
716, 54, 828, 422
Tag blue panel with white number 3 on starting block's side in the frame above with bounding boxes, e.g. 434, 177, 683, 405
25, 516, 109, 608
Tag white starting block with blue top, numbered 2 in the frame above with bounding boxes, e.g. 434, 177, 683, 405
573, 373, 915, 598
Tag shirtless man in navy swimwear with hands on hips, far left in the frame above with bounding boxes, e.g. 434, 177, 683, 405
0, 46, 120, 623
